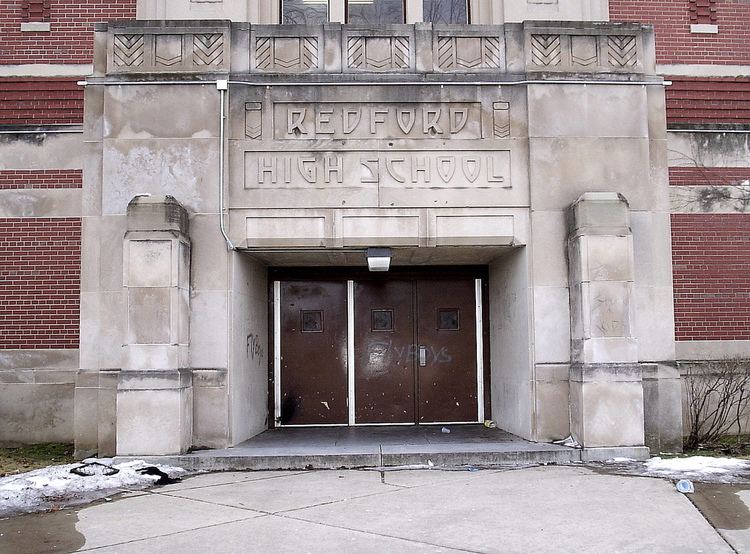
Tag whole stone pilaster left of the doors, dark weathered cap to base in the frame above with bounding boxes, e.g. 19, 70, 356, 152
117, 196, 193, 455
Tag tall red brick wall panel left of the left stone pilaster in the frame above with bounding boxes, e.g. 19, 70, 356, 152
0, 218, 81, 349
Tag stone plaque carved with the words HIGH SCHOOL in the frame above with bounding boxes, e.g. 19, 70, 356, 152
245, 150, 511, 189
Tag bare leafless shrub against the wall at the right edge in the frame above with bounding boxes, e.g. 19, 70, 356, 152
684, 358, 750, 449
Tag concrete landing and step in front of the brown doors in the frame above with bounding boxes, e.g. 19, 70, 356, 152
117, 425, 636, 471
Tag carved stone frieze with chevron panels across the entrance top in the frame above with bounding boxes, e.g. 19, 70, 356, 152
99, 21, 655, 75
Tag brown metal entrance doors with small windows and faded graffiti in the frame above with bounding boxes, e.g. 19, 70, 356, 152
280, 278, 478, 425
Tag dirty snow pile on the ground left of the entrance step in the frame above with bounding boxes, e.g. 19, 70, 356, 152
0, 459, 186, 517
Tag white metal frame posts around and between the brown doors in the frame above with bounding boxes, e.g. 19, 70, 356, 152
273, 272, 485, 427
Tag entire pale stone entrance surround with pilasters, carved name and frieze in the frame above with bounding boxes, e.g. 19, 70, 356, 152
75, 21, 681, 458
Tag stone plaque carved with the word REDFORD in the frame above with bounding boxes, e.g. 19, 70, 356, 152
273, 102, 482, 140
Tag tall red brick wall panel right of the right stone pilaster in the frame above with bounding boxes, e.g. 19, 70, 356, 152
672, 214, 750, 341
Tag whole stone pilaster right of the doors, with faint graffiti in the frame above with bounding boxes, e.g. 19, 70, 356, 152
568, 192, 644, 449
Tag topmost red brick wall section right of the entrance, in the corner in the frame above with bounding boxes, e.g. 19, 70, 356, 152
609, 0, 750, 65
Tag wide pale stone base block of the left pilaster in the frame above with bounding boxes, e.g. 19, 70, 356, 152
117, 370, 193, 456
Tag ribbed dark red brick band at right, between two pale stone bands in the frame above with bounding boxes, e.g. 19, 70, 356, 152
666, 77, 750, 126
